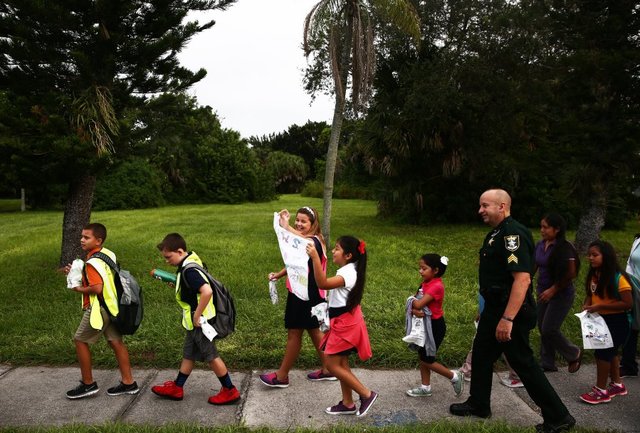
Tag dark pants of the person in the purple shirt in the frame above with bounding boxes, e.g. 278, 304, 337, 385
538, 294, 580, 369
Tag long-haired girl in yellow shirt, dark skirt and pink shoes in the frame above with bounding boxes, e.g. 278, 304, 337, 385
580, 240, 632, 404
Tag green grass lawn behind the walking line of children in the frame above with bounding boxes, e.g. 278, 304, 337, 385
0, 195, 635, 369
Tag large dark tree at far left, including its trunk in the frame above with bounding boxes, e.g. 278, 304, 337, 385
0, 0, 234, 264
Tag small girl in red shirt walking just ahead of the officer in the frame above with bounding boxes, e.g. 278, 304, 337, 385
407, 254, 464, 397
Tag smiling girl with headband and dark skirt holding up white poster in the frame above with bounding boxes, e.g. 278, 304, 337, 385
260, 206, 336, 388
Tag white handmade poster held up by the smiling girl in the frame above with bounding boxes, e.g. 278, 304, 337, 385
273, 212, 309, 301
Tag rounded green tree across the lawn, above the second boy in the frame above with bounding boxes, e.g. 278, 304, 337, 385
131, 94, 275, 203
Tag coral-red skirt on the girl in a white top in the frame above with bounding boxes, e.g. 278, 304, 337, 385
320, 305, 372, 361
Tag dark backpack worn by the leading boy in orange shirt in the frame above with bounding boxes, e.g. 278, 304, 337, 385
91, 252, 143, 335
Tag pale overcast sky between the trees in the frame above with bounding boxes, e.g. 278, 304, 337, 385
179, 0, 333, 138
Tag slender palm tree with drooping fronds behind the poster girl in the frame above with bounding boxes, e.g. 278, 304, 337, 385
303, 0, 420, 242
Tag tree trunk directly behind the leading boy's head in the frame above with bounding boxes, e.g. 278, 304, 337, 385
60, 174, 96, 267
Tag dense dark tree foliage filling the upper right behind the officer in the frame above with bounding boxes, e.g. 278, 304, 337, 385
357, 0, 640, 230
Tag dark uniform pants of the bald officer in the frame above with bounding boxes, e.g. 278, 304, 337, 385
469, 302, 569, 423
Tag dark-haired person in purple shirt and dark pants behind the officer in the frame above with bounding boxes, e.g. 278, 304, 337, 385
535, 213, 582, 373
